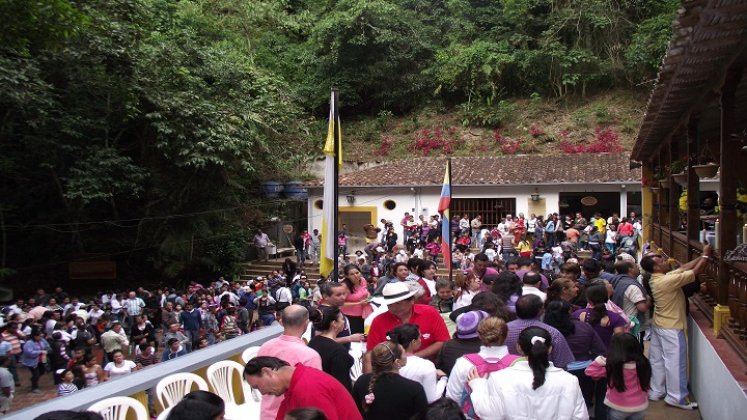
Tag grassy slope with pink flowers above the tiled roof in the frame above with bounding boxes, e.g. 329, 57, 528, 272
344, 91, 647, 162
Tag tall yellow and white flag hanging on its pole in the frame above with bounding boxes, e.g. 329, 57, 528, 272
319, 91, 342, 277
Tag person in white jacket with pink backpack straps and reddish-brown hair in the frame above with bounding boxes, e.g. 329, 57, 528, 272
446, 311, 520, 419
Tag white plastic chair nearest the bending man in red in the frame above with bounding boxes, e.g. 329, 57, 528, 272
207, 360, 262, 420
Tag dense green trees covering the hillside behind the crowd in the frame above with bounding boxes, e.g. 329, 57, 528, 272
0, 0, 679, 286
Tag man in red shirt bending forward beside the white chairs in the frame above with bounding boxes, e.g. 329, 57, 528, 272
244, 356, 361, 420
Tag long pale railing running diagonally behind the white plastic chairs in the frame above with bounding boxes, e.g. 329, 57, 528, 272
3, 324, 283, 420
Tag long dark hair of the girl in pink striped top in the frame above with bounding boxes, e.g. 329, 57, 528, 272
606, 334, 651, 392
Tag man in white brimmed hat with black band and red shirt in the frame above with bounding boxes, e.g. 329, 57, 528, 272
366, 282, 450, 360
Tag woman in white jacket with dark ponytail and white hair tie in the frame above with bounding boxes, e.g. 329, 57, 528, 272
469, 327, 589, 420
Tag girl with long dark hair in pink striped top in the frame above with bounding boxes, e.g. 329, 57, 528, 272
586, 334, 651, 420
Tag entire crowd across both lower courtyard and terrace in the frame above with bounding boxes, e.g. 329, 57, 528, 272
0, 210, 710, 419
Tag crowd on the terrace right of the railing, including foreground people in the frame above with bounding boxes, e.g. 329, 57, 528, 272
235, 215, 711, 419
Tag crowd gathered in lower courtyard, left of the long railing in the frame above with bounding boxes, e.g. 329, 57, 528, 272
0, 272, 324, 413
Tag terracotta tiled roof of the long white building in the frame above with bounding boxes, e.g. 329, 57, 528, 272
310, 153, 641, 187
